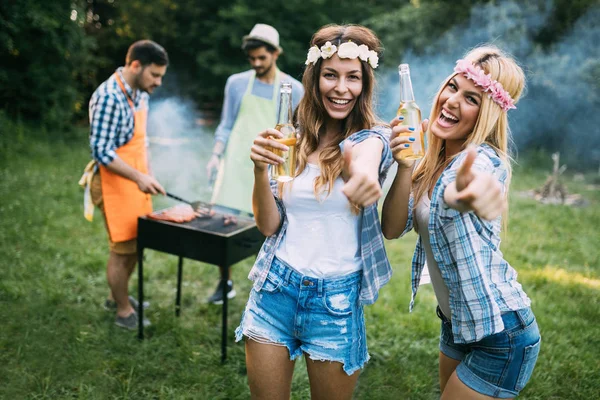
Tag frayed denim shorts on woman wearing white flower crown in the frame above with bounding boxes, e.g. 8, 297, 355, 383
235, 258, 369, 375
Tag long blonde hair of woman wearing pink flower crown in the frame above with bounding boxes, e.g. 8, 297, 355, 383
412, 45, 525, 222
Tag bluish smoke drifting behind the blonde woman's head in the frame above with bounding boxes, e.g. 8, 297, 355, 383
377, 1, 600, 170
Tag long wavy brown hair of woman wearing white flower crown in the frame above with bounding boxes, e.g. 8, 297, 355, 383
296, 24, 382, 198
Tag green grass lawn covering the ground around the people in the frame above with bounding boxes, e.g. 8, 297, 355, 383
0, 132, 600, 400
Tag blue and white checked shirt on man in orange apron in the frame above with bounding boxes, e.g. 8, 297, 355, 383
89, 67, 148, 165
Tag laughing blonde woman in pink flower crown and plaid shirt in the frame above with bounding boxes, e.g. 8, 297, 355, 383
382, 46, 540, 400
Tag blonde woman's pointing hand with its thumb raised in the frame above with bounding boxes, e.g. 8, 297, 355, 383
444, 146, 506, 220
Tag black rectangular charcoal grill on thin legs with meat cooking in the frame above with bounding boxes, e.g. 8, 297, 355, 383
137, 205, 264, 362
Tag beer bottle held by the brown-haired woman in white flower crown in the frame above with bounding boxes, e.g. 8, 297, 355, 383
271, 83, 297, 183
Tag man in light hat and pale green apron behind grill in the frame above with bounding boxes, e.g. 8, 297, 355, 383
206, 24, 304, 304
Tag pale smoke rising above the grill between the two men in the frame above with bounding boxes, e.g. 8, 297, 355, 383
148, 97, 214, 204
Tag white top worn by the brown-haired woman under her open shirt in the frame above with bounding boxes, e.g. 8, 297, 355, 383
275, 164, 362, 278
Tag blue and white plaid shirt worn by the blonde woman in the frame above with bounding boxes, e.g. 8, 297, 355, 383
403, 144, 531, 343
